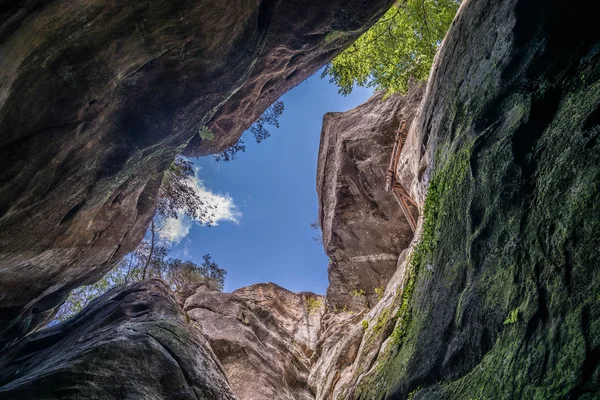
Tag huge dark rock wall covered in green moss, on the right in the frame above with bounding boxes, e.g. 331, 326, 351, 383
342, 0, 600, 400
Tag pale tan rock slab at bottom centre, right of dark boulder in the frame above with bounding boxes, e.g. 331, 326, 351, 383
178, 283, 324, 400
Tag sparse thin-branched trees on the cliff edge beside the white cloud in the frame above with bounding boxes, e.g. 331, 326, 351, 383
55, 157, 227, 321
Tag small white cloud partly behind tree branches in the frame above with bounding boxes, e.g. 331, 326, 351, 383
159, 176, 242, 244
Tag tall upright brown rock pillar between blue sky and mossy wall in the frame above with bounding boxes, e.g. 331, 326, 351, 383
317, 87, 423, 311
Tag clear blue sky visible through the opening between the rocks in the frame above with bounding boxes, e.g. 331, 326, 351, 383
162, 72, 372, 294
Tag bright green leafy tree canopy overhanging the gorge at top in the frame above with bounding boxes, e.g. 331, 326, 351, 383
322, 0, 459, 95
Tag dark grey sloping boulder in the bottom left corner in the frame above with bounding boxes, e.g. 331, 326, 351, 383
0, 280, 236, 400
